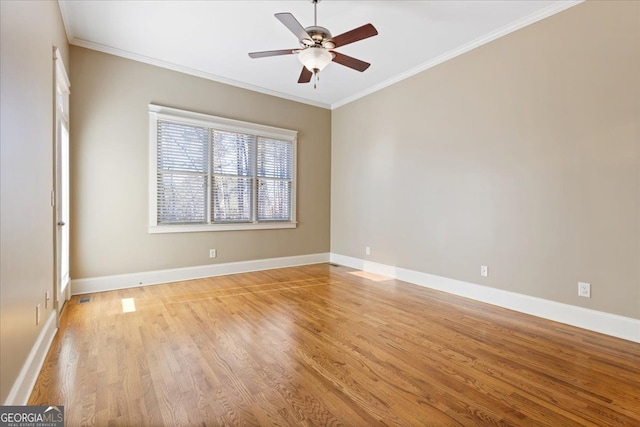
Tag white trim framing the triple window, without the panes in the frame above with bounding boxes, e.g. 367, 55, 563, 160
149, 104, 298, 233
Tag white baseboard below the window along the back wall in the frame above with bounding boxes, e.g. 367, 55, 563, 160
71, 253, 329, 295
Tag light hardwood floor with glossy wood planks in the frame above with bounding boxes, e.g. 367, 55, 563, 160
29, 264, 640, 427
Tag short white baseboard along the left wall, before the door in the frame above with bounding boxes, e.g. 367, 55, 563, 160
3, 311, 58, 406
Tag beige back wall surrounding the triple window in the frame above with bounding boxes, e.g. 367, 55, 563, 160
70, 46, 331, 285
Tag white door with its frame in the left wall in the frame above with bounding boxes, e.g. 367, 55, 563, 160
53, 49, 71, 318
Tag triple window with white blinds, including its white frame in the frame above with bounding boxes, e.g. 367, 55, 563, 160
149, 105, 297, 233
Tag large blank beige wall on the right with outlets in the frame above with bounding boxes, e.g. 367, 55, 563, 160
331, 1, 640, 318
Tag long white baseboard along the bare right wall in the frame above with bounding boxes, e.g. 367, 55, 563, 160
330, 253, 640, 343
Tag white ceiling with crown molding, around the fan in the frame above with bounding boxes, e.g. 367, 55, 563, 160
59, 0, 579, 108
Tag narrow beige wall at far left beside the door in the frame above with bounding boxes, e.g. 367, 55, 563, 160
0, 1, 69, 404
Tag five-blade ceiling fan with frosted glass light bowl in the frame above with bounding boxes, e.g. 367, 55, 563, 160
249, 0, 378, 88
